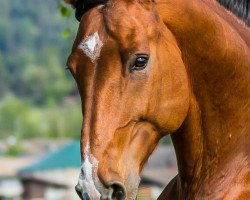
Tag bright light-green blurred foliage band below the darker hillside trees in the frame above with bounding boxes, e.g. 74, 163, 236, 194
0, 95, 82, 139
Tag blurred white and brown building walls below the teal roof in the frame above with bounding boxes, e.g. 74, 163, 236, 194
21, 169, 78, 200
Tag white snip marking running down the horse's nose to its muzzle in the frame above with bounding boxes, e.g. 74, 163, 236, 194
77, 145, 101, 200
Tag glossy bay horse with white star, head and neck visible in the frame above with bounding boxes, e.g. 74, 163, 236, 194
67, 0, 250, 200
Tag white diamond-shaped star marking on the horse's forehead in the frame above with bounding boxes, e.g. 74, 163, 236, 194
78, 32, 103, 63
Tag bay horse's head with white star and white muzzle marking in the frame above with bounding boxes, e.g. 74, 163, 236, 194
68, 0, 189, 200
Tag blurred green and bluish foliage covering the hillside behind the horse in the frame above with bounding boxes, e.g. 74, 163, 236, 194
0, 0, 82, 139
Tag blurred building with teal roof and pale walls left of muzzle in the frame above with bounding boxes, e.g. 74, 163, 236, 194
19, 141, 80, 200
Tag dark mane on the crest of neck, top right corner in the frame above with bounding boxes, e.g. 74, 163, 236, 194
217, 0, 250, 26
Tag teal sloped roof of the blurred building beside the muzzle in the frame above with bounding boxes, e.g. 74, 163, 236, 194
19, 141, 81, 173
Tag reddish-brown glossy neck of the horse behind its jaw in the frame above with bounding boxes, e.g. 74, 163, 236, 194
158, 0, 250, 198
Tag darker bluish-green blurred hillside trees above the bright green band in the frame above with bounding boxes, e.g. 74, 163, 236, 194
0, 0, 77, 105
